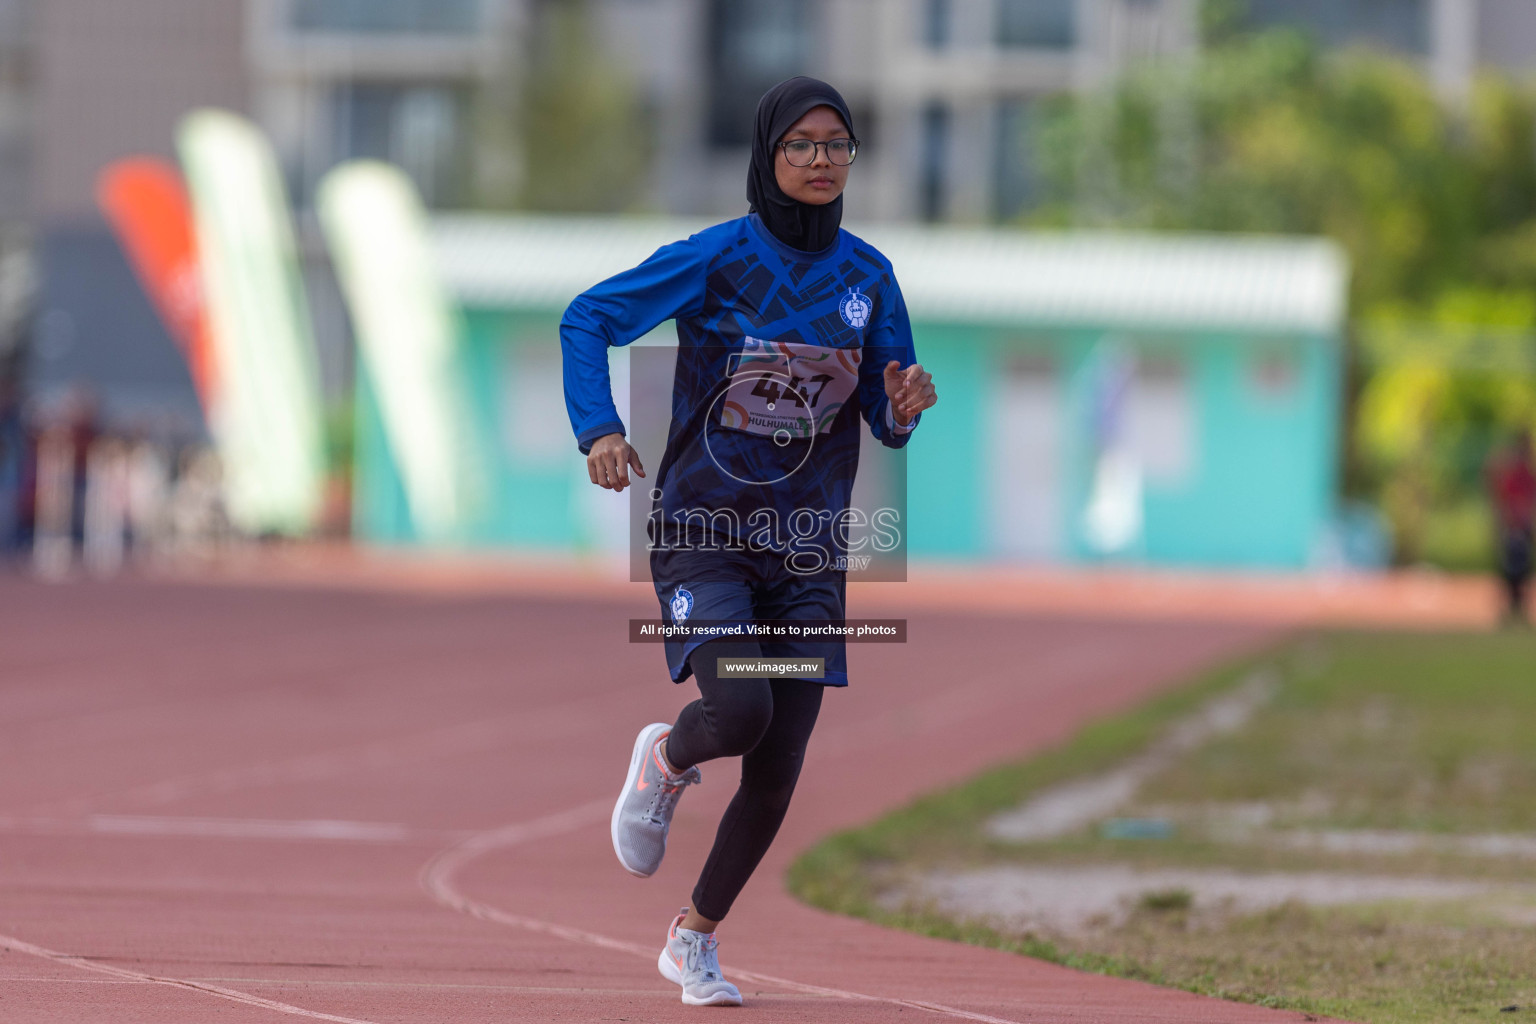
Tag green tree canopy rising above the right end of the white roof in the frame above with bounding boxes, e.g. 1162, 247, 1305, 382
1031, 29, 1536, 309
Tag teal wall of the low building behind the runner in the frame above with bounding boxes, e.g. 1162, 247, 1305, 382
353, 309, 1339, 570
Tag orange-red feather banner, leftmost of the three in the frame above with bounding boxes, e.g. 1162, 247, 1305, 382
97, 157, 218, 425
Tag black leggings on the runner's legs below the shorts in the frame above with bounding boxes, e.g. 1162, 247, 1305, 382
667, 640, 826, 921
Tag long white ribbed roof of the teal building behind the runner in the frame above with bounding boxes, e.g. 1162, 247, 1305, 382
432, 213, 1349, 335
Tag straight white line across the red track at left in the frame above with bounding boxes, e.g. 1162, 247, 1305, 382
0, 814, 467, 843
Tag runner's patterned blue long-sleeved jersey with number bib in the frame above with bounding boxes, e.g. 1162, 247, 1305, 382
561, 215, 917, 571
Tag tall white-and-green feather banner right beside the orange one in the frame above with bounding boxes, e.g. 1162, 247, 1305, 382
177, 109, 324, 534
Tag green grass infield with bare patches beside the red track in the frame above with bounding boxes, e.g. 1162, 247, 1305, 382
788, 633, 1536, 1024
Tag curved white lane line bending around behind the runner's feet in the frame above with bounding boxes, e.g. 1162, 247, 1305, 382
419, 800, 1021, 1024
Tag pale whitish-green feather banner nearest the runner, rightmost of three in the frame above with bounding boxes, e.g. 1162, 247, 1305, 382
316, 161, 482, 542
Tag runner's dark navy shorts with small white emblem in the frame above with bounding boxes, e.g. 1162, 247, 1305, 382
651, 551, 848, 686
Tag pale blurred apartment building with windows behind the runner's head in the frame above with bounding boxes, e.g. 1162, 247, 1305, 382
227, 0, 1536, 223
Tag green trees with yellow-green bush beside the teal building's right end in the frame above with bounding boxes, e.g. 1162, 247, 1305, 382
1029, 23, 1536, 560
